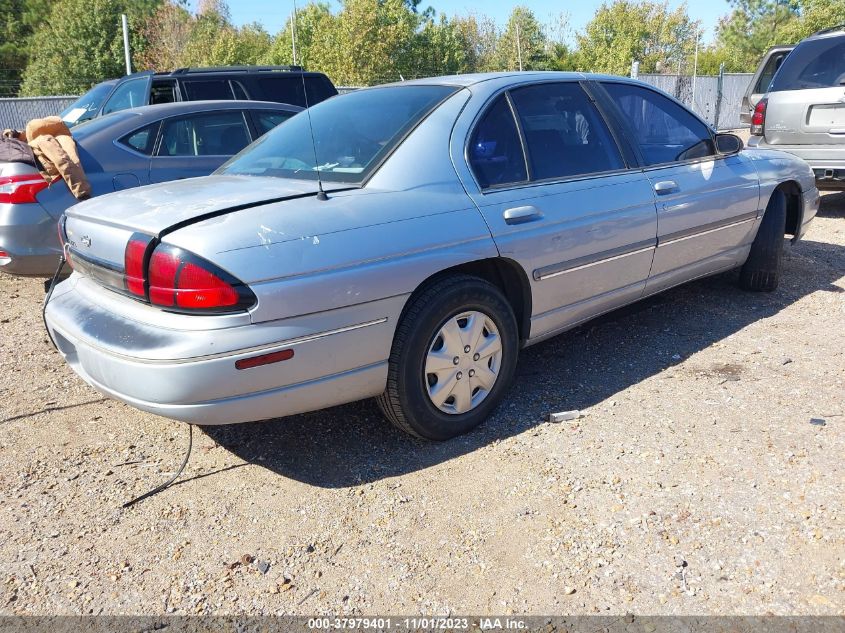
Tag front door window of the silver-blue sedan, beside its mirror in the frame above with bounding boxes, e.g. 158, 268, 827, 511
603, 82, 716, 165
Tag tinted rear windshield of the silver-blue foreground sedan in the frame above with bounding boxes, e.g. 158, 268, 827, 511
216, 85, 457, 184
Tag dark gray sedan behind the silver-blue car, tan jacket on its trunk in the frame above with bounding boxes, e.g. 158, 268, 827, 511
0, 101, 302, 276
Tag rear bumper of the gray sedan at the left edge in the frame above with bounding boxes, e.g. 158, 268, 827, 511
0, 204, 61, 277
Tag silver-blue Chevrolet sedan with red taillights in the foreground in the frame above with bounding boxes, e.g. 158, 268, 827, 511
46, 73, 819, 440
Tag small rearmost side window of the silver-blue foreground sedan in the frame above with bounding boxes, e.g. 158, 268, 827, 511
468, 95, 528, 189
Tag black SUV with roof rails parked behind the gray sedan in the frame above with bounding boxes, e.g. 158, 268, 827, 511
61, 66, 337, 125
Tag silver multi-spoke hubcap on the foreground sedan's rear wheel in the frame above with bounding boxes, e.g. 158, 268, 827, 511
425, 311, 502, 415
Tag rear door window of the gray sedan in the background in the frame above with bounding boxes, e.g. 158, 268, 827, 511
158, 110, 250, 156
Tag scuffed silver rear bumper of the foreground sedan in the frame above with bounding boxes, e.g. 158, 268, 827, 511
46, 275, 401, 424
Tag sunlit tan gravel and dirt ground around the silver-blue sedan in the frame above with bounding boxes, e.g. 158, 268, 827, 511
0, 194, 845, 614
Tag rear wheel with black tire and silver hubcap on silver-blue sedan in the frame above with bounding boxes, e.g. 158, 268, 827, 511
377, 275, 519, 440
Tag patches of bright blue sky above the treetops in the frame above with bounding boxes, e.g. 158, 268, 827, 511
194, 0, 730, 43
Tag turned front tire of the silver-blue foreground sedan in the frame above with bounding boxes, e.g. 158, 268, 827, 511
739, 189, 786, 292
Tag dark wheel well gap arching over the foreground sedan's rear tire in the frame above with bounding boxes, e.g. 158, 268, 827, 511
406, 257, 531, 341
